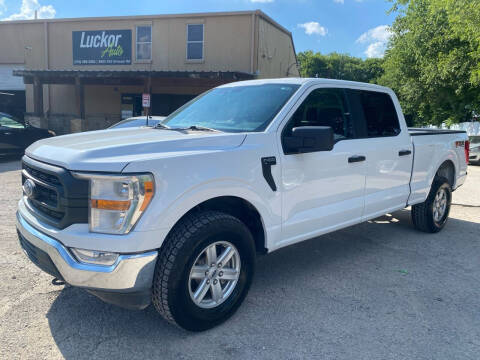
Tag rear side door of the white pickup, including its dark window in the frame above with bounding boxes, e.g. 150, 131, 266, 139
348, 90, 413, 220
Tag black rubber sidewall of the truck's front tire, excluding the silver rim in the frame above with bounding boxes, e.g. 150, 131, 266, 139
168, 218, 255, 331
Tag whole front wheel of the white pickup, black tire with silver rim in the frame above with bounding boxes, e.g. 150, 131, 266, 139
152, 211, 255, 331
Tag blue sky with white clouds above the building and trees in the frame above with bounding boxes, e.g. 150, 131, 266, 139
0, 0, 395, 58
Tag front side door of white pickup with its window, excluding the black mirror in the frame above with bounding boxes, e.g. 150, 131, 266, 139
279, 87, 366, 246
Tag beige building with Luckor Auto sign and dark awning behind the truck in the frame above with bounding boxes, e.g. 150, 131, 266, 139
0, 10, 299, 133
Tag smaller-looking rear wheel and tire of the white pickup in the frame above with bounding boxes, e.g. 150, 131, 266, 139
411, 177, 452, 233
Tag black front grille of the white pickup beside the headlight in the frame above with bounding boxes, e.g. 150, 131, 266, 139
22, 156, 88, 229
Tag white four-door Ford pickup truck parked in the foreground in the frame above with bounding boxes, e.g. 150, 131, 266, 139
17, 79, 468, 331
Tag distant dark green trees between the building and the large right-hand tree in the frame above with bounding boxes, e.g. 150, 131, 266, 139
297, 51, 383, 82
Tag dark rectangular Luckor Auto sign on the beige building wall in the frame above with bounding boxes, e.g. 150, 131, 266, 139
72, 30, 132, 65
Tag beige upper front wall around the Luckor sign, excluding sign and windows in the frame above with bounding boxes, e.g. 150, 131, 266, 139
44, 15, 251, 72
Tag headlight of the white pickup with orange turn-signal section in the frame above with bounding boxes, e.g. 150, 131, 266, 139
75, 173, 155, 234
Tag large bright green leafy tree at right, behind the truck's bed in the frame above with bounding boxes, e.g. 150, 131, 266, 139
379, 0, 480, 125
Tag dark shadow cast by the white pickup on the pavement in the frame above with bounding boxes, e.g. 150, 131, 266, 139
47, 210, 480, 359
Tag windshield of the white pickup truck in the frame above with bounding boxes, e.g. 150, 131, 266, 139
163, 84, 300, 132
